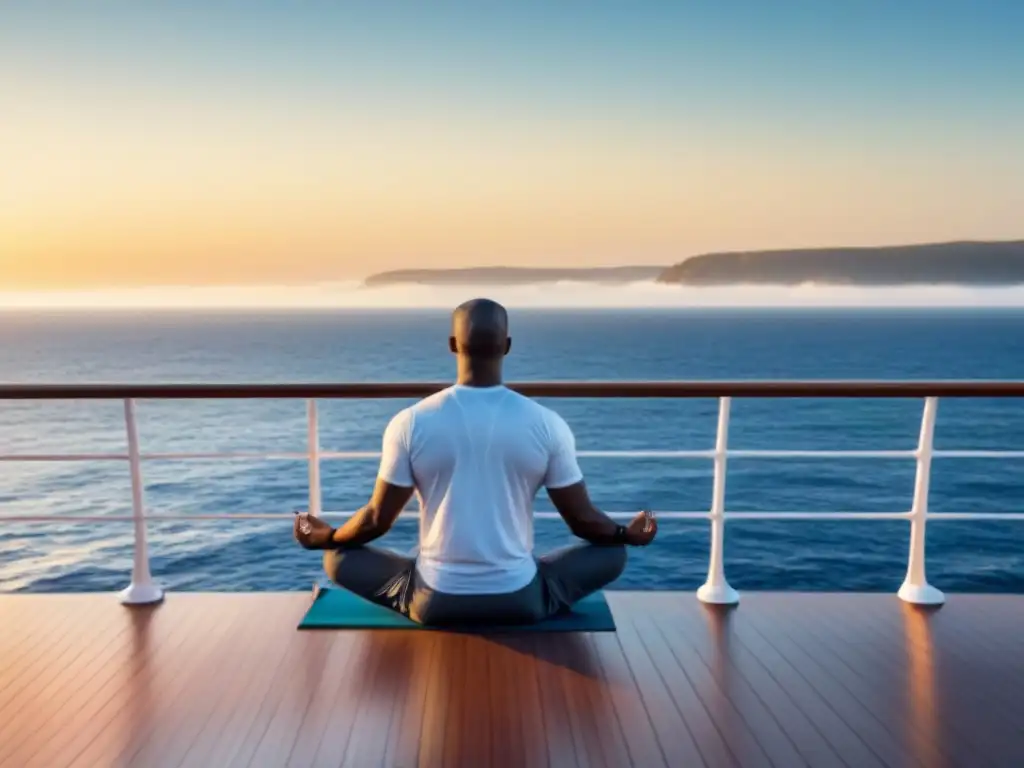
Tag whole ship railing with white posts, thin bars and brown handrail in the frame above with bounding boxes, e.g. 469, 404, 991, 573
0, 381, 1024, 605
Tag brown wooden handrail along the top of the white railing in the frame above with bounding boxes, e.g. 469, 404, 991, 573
0, 380, 1024, 400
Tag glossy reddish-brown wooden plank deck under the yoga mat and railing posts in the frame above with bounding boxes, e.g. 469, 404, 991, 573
0, 592, 1024, 768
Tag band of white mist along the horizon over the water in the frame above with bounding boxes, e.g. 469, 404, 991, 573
0, 281, 1024, 309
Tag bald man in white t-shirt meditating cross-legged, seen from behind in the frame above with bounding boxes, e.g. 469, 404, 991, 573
295, 299, 657, 625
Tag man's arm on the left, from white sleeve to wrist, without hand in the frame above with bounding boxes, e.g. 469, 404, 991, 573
331, 410, 415, 547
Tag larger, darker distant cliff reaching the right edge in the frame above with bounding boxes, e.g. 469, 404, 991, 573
657, 241, 1024, 286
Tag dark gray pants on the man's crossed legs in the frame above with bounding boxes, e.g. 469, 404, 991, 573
324, 544, 626, 626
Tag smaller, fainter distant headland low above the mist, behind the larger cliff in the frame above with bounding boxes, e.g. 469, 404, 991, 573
365, 266, 665, 287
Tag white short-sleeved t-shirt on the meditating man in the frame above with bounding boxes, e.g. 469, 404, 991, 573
379, 385, 583, 595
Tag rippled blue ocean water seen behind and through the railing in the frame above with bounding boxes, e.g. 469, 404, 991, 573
0, 306, 1024, 592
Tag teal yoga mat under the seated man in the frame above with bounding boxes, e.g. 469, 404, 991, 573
299, 589, 615, 635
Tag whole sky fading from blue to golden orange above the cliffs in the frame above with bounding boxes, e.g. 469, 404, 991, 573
0, 0, 1024, 292
